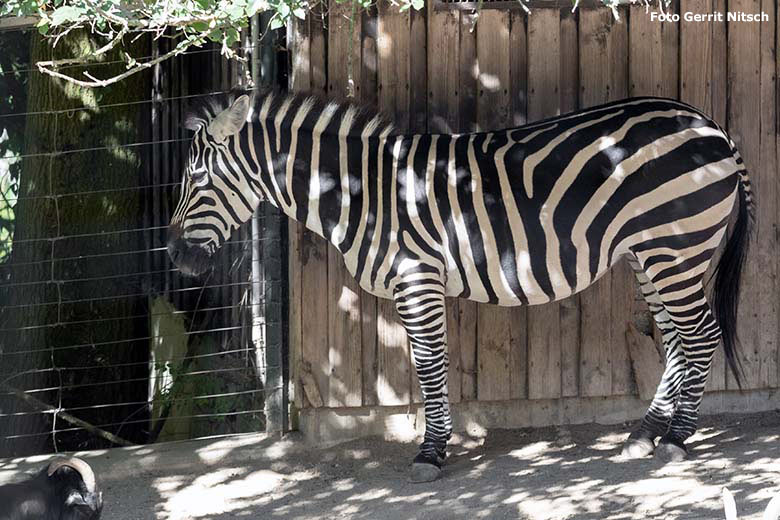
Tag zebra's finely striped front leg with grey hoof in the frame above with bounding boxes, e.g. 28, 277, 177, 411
393, 274, 452, 482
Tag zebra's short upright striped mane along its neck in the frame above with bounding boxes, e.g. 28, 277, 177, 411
184, 89, 394, 136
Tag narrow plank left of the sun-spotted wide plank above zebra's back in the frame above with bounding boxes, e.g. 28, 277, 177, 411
455, 11, 479, 401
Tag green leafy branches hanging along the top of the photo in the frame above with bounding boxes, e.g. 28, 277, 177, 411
0, 0, 652, 87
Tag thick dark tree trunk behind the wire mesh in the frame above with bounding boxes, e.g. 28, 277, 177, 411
0, 32, 150, 455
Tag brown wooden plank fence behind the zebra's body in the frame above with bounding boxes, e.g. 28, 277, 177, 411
289, 0, 780, 438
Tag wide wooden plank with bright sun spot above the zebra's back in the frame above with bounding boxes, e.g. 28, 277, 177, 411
477, 10, 512, 401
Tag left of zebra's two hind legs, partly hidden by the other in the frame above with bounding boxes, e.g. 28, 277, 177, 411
623, 258, 686, 458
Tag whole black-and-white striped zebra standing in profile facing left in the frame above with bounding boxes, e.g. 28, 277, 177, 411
168, 92, 754, 482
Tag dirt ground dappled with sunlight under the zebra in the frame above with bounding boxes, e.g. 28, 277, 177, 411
0, 411, 780, 520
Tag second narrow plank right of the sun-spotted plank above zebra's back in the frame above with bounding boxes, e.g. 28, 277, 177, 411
559, 8, 580, 397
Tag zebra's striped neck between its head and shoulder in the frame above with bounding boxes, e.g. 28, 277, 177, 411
244, 95, 394, 252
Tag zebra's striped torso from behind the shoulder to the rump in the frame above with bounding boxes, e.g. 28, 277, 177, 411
386, 98, 741, 305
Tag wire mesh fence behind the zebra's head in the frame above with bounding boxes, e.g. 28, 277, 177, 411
0, 25, 286, 456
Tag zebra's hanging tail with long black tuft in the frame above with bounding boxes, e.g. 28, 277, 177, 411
713, 158, 755, 389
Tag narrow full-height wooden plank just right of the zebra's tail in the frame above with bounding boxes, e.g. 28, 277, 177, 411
749, 0, 778, 388
